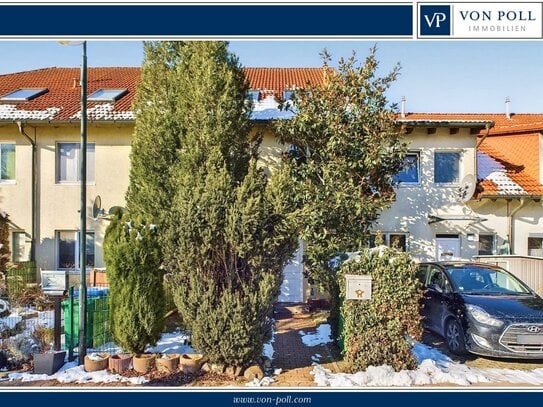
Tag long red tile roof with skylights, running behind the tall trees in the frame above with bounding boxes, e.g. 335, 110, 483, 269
0, 67, 324, 121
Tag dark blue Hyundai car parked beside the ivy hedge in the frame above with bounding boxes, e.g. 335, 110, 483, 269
418, 262, 543, 359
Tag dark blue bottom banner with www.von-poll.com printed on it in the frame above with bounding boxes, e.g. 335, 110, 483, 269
0, 388, 543, 407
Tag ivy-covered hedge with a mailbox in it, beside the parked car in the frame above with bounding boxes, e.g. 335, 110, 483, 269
338, 246, 422, 371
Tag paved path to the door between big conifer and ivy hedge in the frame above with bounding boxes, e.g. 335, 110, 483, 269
273, 304, 339, 387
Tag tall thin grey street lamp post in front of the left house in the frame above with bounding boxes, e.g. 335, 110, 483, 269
60, 41, 87, 365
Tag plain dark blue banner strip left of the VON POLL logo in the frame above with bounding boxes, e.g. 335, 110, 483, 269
0, 4, 413, 37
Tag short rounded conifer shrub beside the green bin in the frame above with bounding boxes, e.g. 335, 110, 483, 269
104, 213, 164, 354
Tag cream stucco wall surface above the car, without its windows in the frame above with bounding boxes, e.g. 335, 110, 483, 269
374, 128, 477, 261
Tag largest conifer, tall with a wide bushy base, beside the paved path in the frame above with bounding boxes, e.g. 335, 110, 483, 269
163, 42, 297, 366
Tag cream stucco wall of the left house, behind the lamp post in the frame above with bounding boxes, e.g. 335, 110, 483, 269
0, 123, 133, 269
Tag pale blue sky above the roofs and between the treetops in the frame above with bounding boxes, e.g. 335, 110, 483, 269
0, 41, 543, 113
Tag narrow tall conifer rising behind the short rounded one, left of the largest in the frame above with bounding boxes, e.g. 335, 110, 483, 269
126, 41, 184, 221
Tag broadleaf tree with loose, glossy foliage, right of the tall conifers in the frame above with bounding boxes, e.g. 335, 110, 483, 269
275, 48, 406, 331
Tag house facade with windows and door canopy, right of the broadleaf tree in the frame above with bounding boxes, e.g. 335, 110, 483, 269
374, 123, 490, 261
